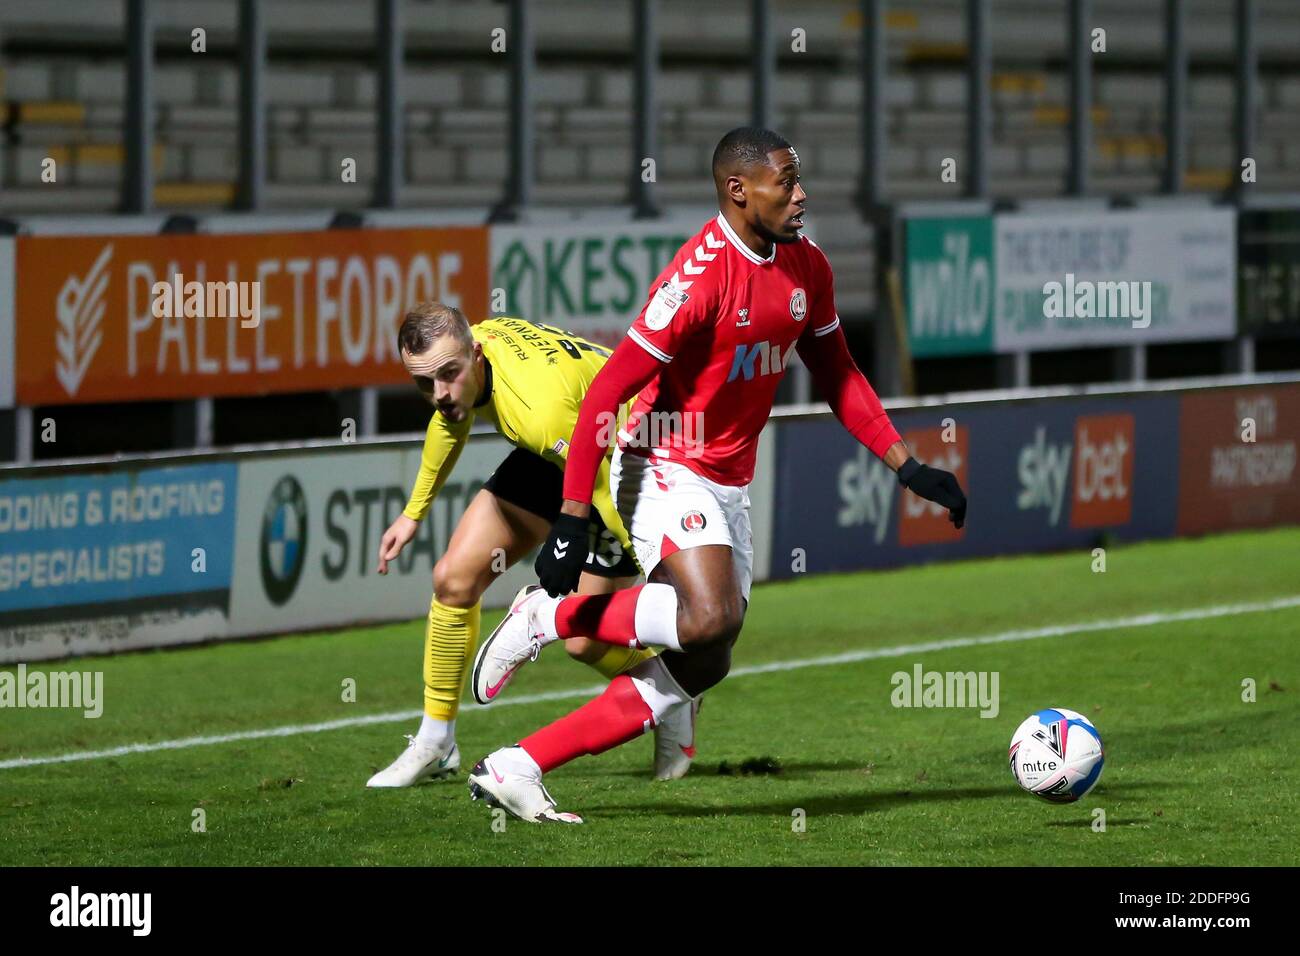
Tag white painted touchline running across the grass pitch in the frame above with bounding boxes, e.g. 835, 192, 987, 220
0, 594, 1300, 770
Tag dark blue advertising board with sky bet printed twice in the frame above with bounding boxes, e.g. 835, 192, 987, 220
772, 395, 1179, 578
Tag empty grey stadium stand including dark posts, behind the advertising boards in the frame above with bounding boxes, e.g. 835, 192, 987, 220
0, 0, 1300, 460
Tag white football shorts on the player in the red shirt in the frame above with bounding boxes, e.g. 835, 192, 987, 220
610, 449, 754, 601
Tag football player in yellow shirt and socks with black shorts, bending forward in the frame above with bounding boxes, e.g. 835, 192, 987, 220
367, 302, 696, 787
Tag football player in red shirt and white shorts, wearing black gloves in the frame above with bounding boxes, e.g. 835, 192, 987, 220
469, 127, 966, 823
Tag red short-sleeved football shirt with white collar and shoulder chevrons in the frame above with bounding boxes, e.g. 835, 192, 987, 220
619, 213, 840, 486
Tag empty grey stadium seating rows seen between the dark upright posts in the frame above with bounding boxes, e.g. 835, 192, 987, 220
0, 0, 1300, 310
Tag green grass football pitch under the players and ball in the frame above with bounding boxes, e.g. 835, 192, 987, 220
0, 528, 1300, 866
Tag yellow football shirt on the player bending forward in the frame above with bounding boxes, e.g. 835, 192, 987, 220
403, 316, 634, 564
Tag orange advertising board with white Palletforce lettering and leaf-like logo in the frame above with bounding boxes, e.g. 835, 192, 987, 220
16, 226, 488, 405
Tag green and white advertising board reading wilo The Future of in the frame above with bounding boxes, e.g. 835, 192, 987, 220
905, 209, 1236, 358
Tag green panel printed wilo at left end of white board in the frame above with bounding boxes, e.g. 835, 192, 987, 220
906, 216, 995, 358
